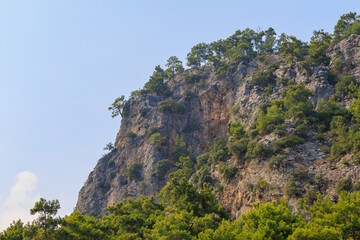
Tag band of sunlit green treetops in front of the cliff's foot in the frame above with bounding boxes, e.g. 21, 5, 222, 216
5, 185, 360, 240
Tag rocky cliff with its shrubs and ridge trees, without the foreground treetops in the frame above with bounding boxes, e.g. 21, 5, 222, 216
76, 29, 360, 218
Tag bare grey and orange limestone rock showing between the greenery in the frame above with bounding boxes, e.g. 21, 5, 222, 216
76, 35, 360, 217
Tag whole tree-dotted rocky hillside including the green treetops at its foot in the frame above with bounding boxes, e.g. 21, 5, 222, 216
0, 13, 360, 240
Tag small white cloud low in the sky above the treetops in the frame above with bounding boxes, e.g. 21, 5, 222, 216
0, 171, 40, 231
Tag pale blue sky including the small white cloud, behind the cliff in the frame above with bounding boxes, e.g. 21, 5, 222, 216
0, 0, 360, 230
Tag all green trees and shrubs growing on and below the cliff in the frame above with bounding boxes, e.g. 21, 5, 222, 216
0, 13, 360, 239
